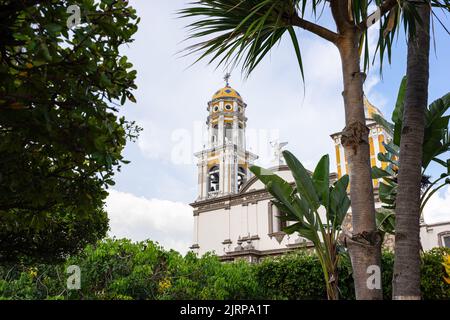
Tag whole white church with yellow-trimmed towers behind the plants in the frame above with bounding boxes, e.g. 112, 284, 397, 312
190, 75, 450, 262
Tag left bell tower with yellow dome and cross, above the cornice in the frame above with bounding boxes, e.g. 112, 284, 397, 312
195, 74, 257, 201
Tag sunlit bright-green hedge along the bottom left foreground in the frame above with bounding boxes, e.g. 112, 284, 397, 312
0, 239, 261, 300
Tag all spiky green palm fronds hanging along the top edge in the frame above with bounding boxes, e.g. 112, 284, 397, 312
178, 0, 450, 79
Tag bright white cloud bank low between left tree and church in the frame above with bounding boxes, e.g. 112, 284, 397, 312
106, 190, 193, 254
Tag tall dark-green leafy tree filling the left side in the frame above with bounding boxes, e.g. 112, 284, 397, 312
0, 0, 140, 262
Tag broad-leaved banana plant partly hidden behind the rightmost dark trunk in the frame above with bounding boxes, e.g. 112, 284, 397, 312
372, 77, 450, 234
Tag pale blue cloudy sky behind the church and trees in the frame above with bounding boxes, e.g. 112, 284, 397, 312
106, 0, 450, 253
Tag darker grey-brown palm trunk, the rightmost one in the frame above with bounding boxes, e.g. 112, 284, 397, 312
392, 4, 430, 300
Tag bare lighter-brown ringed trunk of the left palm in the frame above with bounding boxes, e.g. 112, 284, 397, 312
337, 28, 383, 300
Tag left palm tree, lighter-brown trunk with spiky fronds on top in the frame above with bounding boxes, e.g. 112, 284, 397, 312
179, 0, 436, 299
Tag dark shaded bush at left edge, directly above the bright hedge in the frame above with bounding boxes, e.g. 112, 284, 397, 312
0, 207, 108, 264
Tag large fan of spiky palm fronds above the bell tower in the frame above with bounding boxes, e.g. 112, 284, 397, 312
178, 0, 325, 78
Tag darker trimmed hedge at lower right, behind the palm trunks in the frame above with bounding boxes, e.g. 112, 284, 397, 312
255, 248, 450, 300
